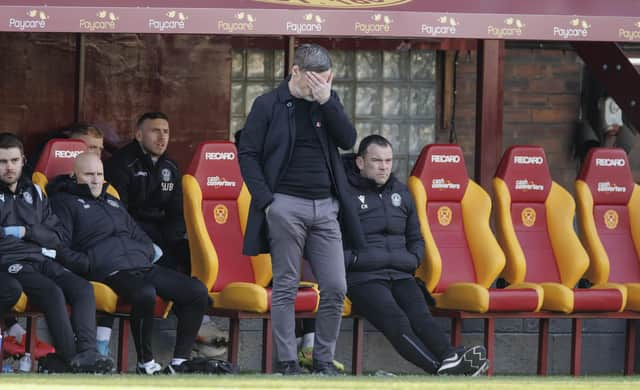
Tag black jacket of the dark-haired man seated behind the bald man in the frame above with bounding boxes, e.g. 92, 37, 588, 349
105, 140, 186, 245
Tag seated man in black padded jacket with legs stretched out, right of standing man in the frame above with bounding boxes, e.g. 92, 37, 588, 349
344, 135, 489, 376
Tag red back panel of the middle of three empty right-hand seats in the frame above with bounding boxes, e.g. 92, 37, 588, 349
496, 146, 561, 283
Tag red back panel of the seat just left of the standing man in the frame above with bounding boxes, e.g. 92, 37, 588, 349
186, 141, 255, 291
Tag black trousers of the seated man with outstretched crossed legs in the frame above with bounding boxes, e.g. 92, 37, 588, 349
347, 278, 453, 373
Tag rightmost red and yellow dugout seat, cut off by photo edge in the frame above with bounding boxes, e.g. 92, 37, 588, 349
576, 148, 640, 311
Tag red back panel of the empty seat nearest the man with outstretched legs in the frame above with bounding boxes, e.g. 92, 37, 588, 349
411, 144, 476, 293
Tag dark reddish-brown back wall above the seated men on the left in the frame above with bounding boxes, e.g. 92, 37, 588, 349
0, 32, 231, 169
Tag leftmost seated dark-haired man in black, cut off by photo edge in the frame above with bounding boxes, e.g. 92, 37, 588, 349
0, 133, 113, 372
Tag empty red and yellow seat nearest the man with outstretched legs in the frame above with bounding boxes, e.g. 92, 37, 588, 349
408, 144, 543, 313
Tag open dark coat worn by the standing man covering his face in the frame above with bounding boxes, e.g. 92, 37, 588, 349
238, 78, 364, 255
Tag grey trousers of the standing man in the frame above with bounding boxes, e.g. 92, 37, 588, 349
266, 194, 347, 362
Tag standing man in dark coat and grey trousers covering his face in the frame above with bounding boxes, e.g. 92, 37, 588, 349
239, 44, 364, 375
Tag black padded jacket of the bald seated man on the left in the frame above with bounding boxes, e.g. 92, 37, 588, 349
47, 175, 154, 281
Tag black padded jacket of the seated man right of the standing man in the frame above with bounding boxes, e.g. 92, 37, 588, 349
344, 156, 424, 285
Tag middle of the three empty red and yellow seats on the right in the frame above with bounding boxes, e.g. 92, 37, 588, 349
493, 146, 626, 313
